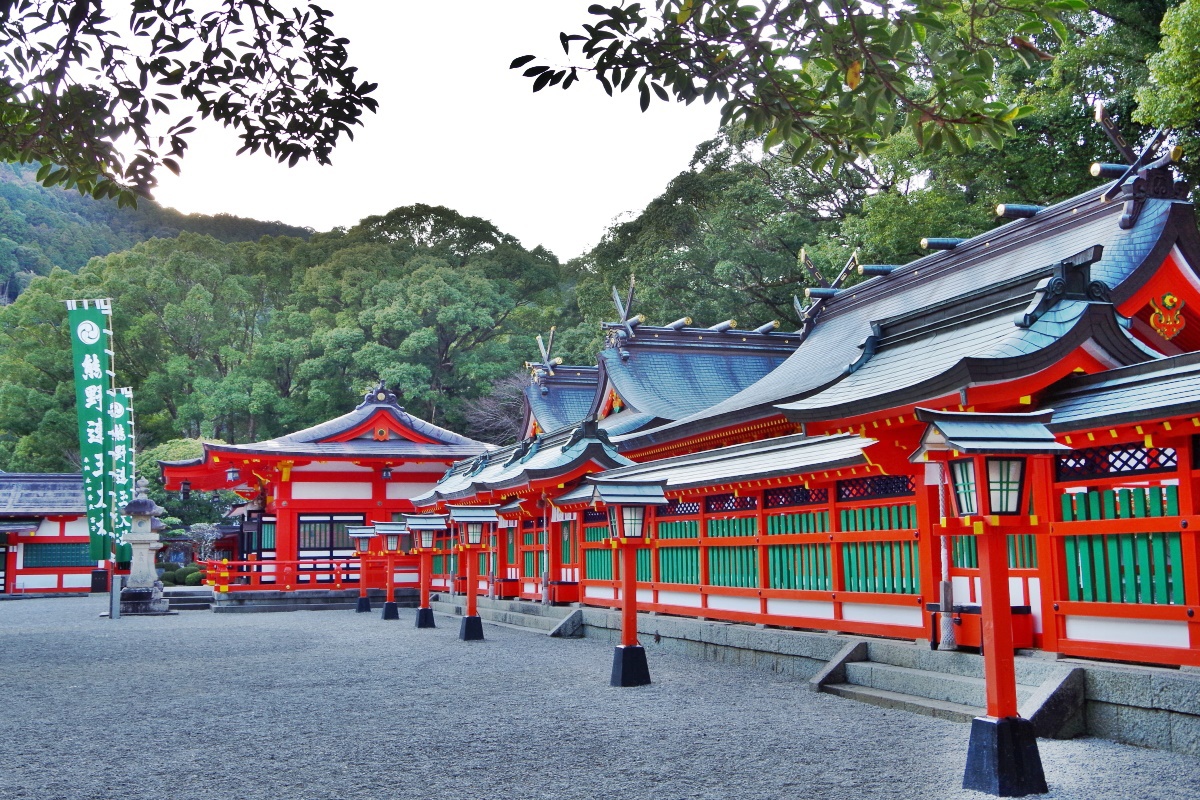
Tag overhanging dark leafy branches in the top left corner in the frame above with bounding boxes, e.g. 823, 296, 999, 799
0, 0, 376, 204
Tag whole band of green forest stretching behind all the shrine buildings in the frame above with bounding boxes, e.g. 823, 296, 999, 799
0, 0, 1180, 470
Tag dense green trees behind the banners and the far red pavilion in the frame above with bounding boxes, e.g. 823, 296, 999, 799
0, 205, 578, 479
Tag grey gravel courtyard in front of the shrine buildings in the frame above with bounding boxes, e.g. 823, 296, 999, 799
0, 596, 1200, 800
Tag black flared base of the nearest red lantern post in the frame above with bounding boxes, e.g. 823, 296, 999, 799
962, 717, 1050, 798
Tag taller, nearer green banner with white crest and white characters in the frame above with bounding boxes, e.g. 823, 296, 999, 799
67, 300, 113, 561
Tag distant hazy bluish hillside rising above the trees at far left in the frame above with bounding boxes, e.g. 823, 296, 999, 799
0, 164, 312, 303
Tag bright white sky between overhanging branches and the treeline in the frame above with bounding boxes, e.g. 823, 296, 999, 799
155, 0, 719, 260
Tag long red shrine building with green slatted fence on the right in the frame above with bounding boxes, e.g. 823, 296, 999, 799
414, 160, 1200, 666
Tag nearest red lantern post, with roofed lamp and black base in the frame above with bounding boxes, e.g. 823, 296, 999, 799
913, 408, 1069, 796
